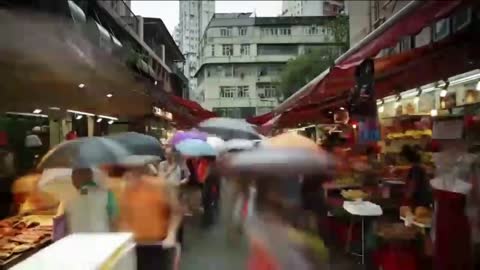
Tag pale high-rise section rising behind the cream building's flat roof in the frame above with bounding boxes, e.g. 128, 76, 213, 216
282, 0, 345, 16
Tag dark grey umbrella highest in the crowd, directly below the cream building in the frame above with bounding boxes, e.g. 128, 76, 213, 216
198, 117, 260, 140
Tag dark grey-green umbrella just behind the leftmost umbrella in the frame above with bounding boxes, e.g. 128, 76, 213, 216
105, 132, 164, 158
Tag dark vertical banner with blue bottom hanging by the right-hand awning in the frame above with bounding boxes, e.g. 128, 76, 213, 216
349, 59, 380, 143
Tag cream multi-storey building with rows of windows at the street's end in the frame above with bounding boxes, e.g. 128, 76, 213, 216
196, 13, 340, 118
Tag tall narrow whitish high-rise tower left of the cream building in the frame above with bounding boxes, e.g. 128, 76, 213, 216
175, 0, 215, 100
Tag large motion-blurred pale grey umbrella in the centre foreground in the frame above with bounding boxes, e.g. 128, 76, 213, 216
220, 148, 334, 176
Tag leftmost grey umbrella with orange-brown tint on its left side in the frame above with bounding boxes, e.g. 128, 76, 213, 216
38, 137, 131, 169
